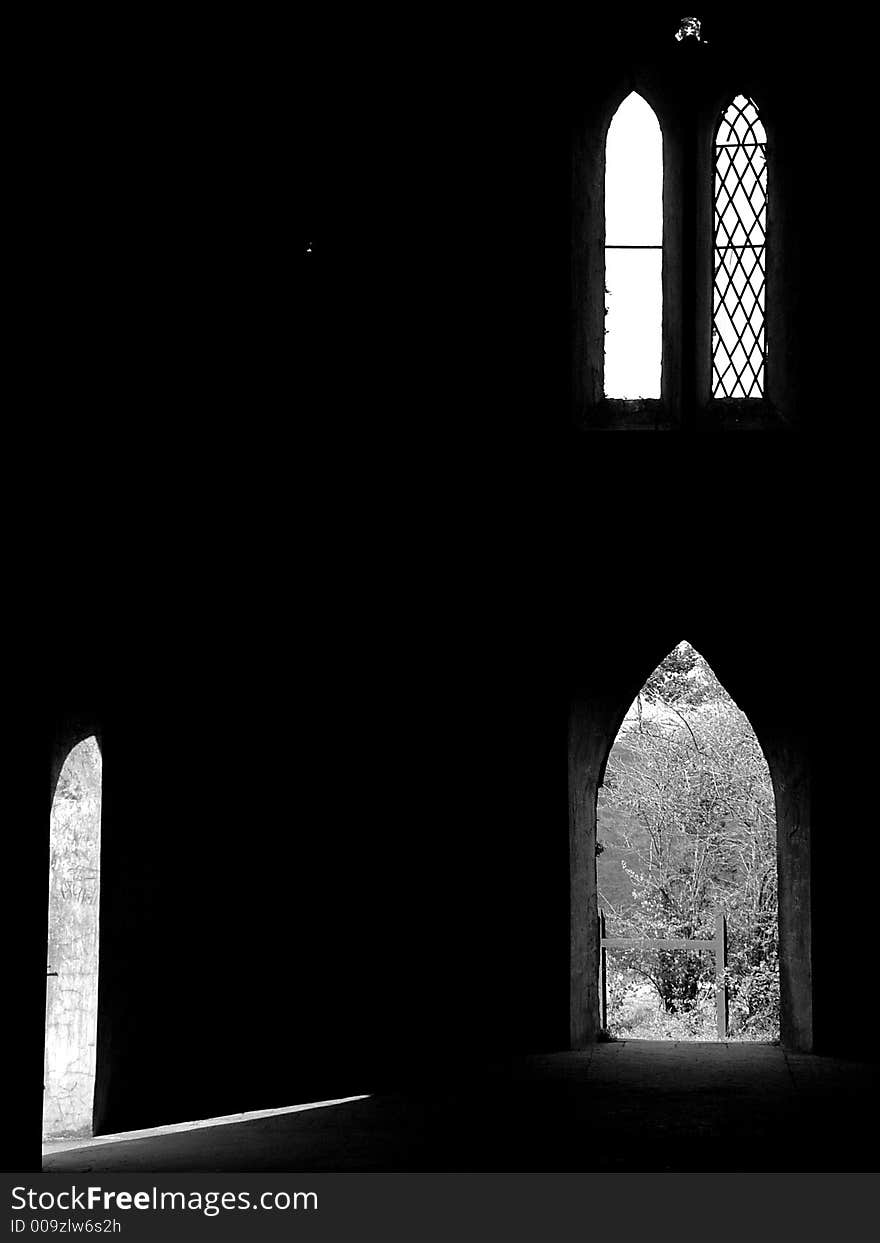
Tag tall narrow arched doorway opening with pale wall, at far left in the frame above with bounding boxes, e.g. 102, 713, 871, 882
42, 737, 102, 1140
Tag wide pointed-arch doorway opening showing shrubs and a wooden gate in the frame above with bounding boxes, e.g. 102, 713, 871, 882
597, 643, 779, 1042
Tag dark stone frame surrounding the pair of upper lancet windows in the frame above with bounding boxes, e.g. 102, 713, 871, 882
572, 75, 792, 431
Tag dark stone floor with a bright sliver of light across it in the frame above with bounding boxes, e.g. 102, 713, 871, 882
44, 1040, 879, 1172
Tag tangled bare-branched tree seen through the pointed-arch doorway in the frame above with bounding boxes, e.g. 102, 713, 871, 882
598, 649, 778, 1033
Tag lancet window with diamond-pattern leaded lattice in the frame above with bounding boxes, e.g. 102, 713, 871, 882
712, 94, 767, 398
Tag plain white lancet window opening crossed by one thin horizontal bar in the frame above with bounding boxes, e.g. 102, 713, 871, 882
605, 92, 662, 398
